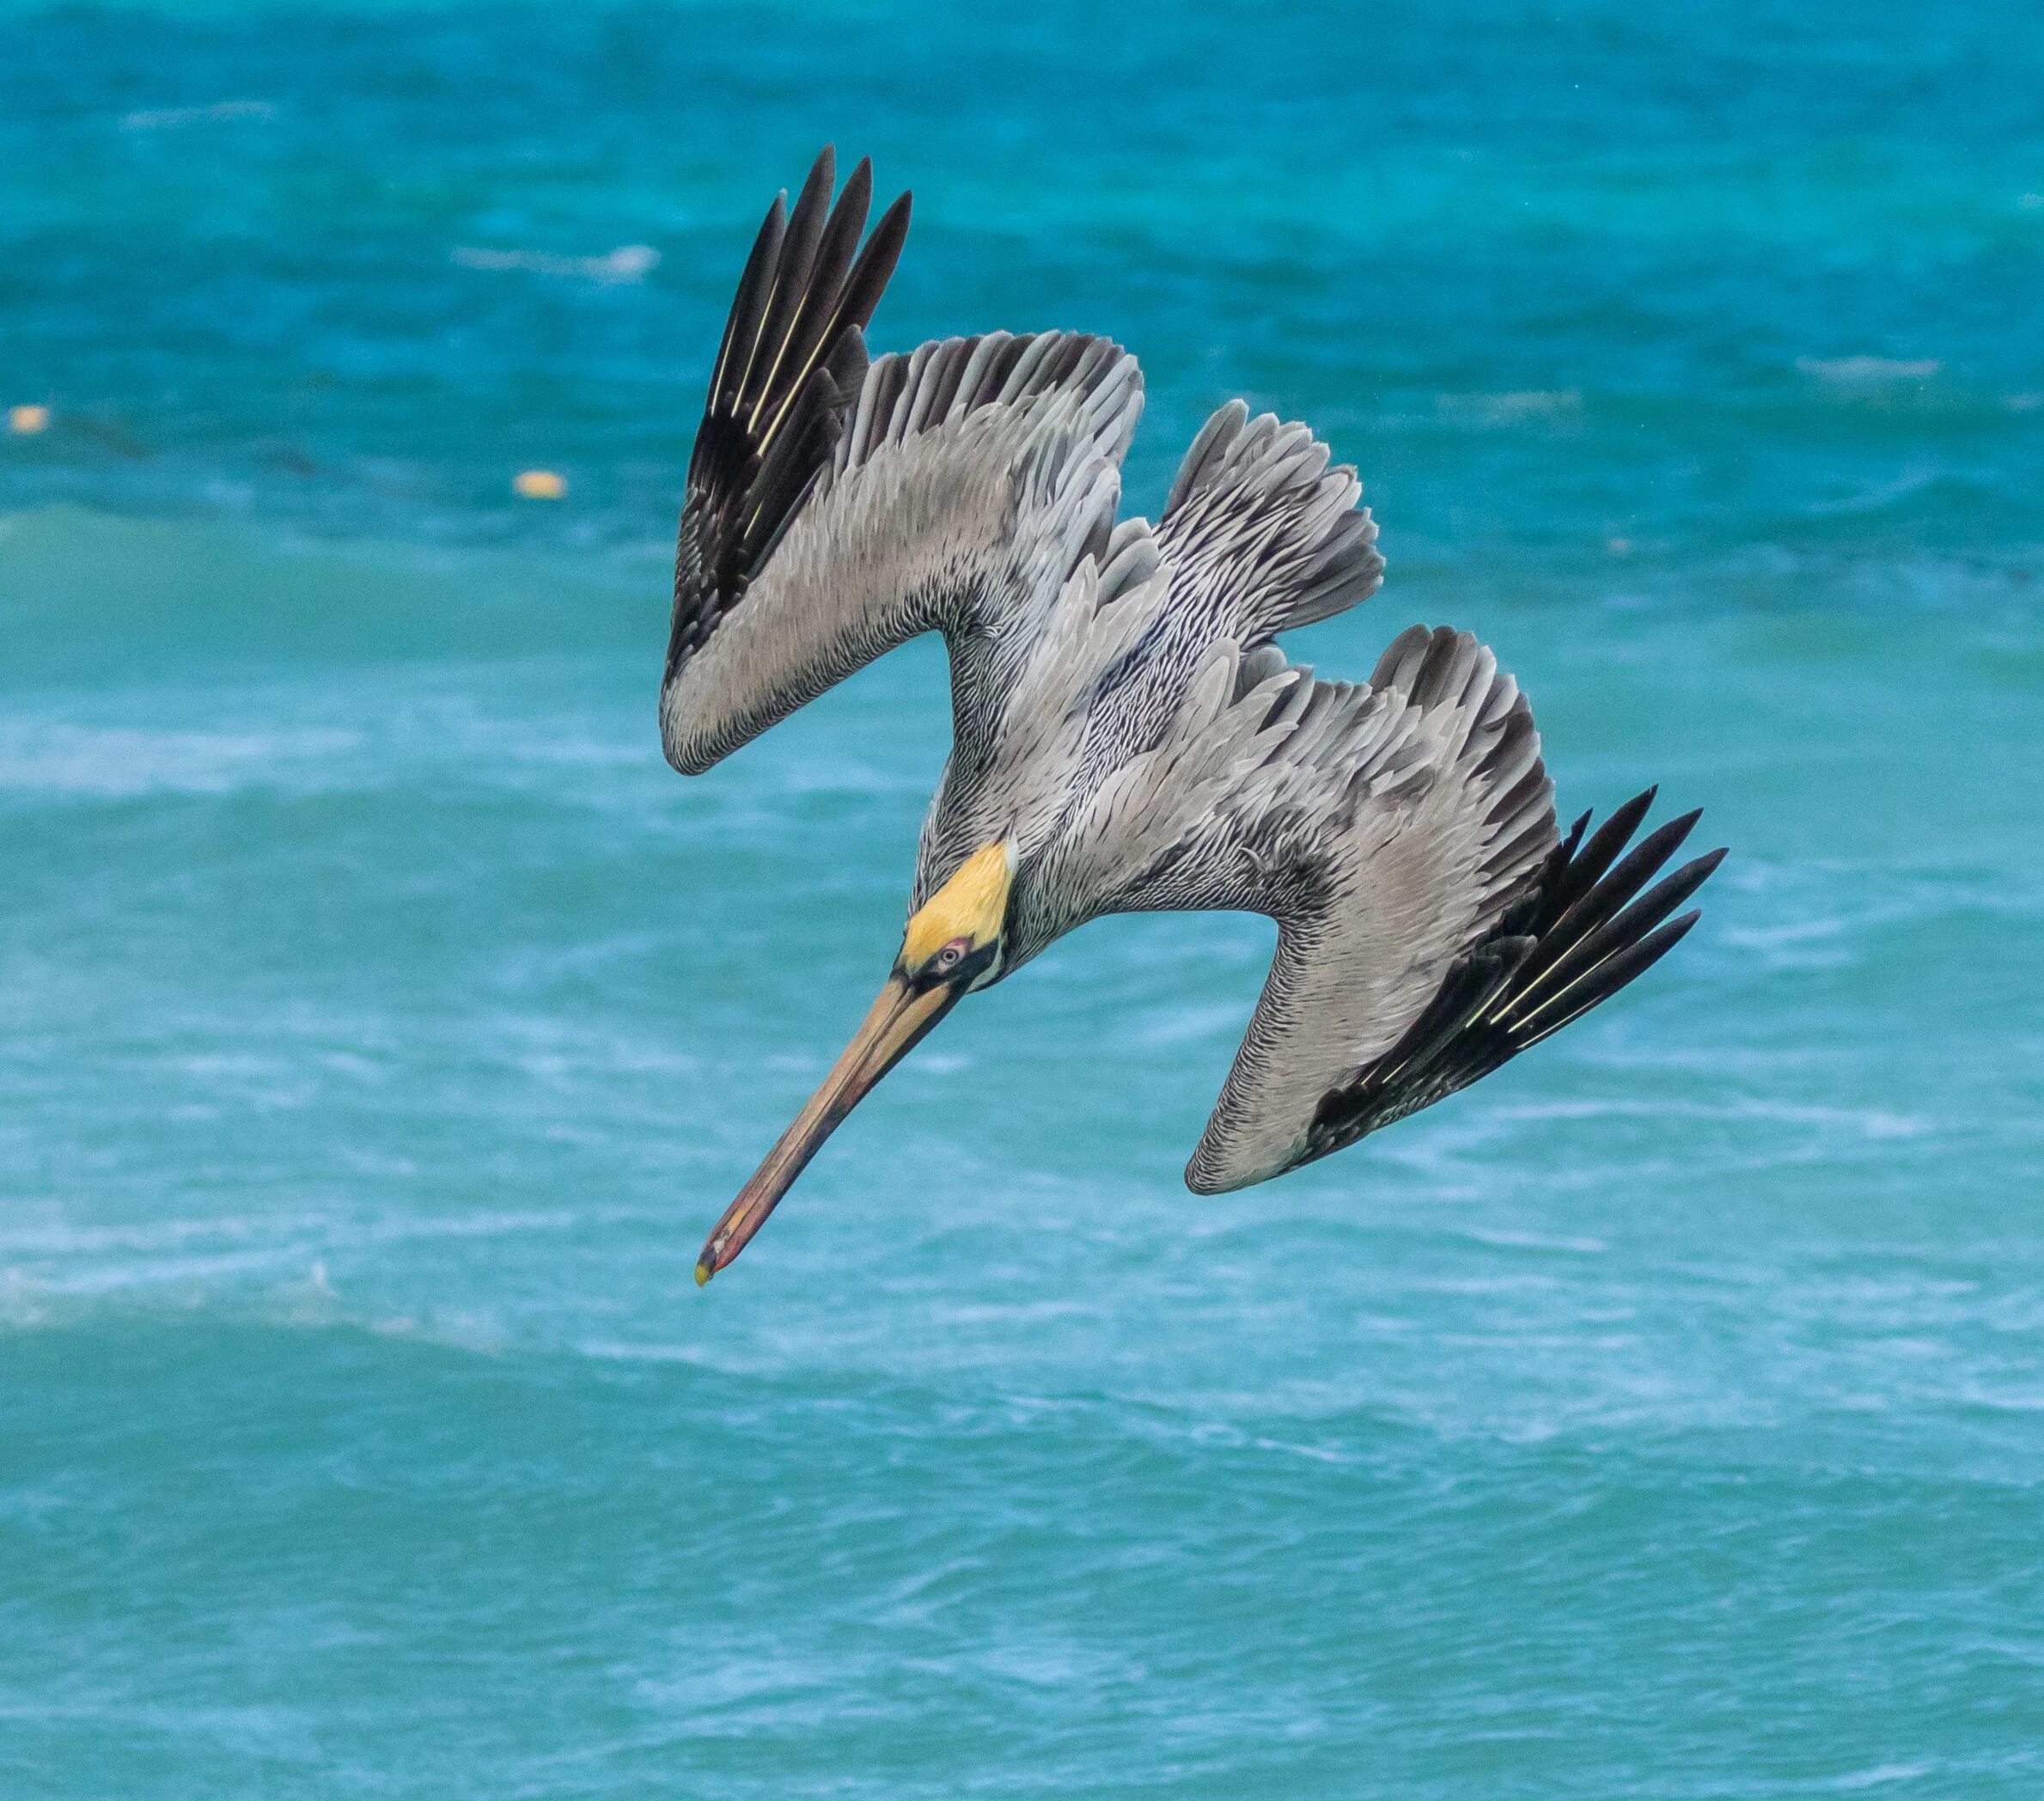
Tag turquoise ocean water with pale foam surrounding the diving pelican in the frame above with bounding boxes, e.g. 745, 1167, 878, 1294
0, 0, 2044, 1801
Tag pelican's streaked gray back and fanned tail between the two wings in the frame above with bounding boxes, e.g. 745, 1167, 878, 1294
985, 400, 1384, 928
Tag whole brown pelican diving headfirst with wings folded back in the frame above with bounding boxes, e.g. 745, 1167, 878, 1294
660, 150, 1723, 1282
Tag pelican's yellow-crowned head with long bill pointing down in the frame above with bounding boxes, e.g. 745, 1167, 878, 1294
695, 838, 1016, 1284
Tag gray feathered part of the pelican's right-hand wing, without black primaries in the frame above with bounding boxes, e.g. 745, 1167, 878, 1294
1161, 627, 1553, 1192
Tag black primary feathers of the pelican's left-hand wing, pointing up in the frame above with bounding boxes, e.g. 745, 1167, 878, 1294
667, 147, 910, 676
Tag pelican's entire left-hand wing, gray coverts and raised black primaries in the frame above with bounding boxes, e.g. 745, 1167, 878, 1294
660, 151, 1143, 775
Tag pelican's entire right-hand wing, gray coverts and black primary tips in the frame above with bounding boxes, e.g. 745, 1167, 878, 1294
1186, 627, 1723, 1194
